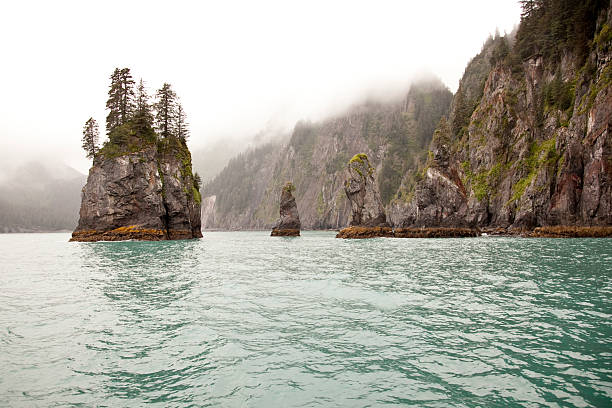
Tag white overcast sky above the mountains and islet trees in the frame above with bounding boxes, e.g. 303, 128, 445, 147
0, 0, 520, 172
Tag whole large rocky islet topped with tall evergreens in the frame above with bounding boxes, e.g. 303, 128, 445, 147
70, 68, 202, 242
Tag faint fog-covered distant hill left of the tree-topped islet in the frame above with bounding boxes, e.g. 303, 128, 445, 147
0, 162, 86, 232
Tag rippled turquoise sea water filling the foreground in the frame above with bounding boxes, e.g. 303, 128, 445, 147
0, 232, 612, 407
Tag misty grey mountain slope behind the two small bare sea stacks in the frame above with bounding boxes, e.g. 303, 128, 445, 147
202, 80, 452, 229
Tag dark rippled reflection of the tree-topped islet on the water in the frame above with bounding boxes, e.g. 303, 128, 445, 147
75, 240, 202, 401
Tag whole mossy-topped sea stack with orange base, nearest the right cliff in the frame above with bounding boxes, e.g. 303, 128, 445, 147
336, 153, 393, 238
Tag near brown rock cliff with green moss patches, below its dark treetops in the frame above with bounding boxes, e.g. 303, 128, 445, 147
390, 7, 612, 229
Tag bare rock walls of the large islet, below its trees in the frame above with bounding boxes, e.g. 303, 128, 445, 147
72, 141, 202, 241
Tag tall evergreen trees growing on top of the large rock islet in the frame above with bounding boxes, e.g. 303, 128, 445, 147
82, 68, 189, 158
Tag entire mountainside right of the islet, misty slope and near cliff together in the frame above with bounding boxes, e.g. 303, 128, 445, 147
205, 0, 612, 229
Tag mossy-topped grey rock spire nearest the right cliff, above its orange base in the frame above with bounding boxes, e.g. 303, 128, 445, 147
344, 153, 389, 227
